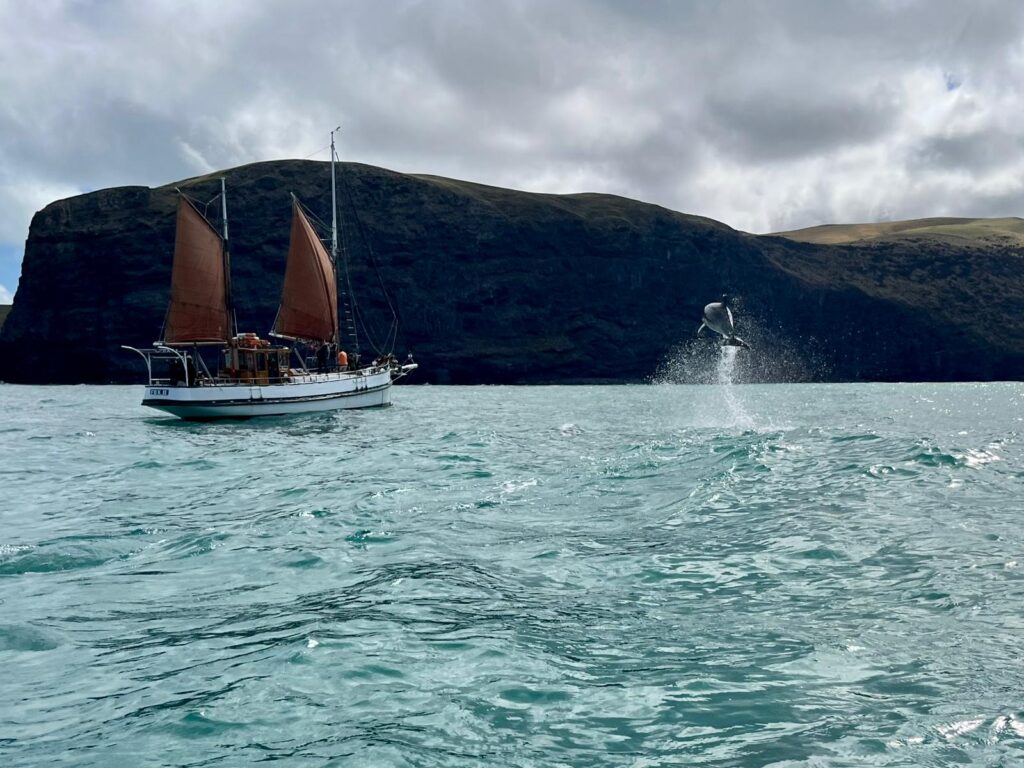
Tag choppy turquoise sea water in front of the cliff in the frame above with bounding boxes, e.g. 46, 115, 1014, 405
0, 384, 1024, 767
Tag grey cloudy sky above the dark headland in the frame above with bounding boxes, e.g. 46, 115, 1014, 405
0, 0, 1024, 303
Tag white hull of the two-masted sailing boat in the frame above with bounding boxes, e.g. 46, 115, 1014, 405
142, 368, 391, 419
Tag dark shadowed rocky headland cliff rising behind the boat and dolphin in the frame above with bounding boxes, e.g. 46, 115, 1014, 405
0, 161, 1024, 383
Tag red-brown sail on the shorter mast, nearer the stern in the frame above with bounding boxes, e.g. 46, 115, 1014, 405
164, 198, 231, 344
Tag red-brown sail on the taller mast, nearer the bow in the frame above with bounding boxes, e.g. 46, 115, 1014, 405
273, 203, 338, 341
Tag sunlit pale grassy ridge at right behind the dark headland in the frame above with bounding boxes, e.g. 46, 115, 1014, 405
772, 216, 1024, 246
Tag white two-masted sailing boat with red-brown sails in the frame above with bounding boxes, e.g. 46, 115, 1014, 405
123, 131, 417, 420
